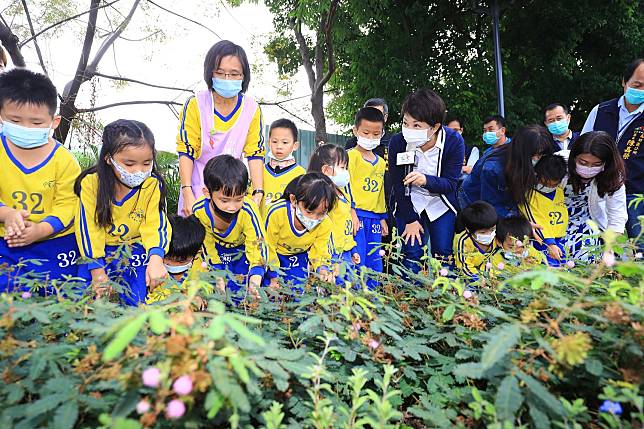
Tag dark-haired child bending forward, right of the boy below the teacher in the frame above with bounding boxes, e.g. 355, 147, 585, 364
266, 173, 338, 286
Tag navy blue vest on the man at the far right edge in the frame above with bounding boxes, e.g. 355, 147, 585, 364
593, 98, 644, 194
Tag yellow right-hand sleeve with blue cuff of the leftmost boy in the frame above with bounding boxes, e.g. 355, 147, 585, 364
41, 148, 80, 234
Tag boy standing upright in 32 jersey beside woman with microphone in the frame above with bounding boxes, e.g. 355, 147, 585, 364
347, 107, 389, 288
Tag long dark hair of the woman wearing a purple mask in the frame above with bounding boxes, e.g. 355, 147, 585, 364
568, 131, 626, 197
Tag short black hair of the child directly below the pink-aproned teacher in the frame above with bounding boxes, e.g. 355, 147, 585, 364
203, 155, 248, 197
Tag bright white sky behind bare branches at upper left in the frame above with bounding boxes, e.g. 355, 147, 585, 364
0, 0, 342, 151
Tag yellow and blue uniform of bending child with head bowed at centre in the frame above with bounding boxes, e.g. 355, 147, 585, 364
266, 200, 332, 285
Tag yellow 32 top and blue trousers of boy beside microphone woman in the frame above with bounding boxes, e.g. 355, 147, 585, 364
347, 149, 387, 288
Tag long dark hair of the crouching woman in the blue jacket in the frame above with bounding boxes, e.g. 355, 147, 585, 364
499, 125, 552, 205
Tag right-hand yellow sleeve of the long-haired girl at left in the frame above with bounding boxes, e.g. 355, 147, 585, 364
140, 179, 172, 258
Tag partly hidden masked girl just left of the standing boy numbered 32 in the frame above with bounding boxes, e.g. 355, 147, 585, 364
309, 144, 360, 277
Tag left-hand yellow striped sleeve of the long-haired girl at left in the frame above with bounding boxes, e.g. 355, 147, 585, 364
74, 176, 106, 270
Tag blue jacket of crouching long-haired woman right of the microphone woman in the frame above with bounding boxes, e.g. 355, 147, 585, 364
461, 145, 519, 217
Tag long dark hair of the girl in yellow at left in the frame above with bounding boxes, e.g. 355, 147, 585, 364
74, 119, 166, 228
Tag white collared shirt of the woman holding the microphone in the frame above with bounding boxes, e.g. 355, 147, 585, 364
411, 129, 449, 222
